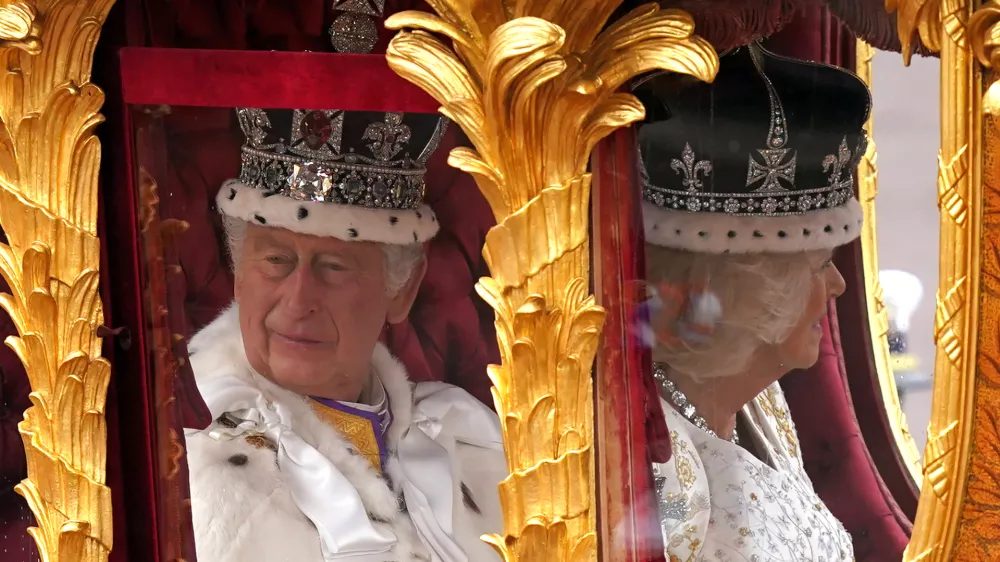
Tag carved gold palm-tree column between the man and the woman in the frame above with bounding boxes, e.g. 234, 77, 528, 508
386, 0, 718, 562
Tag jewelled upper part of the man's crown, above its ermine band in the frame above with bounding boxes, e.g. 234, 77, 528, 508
236, 108, 448, 209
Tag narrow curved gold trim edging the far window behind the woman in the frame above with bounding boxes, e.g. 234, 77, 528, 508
855, 40, 923, 487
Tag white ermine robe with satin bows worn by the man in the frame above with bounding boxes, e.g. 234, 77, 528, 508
185, 305, 506, 562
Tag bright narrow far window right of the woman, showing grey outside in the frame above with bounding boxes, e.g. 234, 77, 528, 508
860, 51, 940, 476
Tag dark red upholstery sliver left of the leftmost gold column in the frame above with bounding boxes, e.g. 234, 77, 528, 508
0, 280, 38, 562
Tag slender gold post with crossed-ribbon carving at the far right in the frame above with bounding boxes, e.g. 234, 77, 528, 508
887, 0, 980, 562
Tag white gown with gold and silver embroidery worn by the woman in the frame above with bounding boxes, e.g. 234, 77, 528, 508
653, 383, 854, 562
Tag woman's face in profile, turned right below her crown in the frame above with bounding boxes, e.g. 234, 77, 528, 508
775, 255, 847, 370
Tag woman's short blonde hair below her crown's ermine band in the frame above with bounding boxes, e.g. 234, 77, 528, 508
646, 245, 831, 380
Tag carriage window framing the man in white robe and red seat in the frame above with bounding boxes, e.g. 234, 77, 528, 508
131, 105, 506, 560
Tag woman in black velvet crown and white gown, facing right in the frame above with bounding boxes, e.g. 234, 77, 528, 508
640, 45, 870, 562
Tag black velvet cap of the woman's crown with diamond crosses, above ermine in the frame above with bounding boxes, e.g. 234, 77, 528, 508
634, 44, 871, 216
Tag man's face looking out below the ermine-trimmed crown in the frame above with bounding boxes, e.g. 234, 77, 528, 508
235, 224, 410, 400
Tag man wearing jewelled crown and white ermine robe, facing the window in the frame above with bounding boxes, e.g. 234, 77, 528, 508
180, 101, 506, 562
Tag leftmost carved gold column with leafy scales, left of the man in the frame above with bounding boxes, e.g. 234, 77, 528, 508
0, 0, 114, 562
